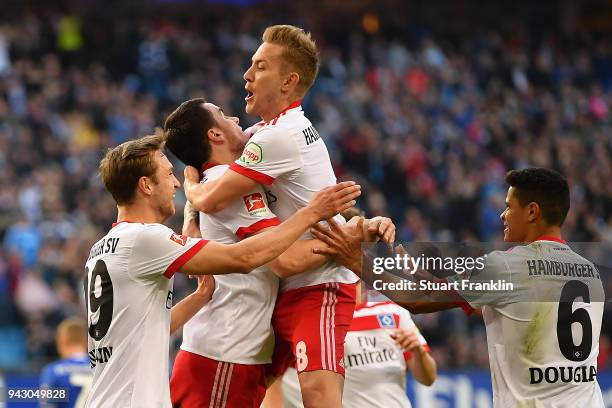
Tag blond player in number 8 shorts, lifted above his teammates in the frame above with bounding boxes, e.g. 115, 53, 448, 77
180, 25, 388, 408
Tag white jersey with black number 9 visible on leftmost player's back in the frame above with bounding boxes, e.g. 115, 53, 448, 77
84, 222, 207, 408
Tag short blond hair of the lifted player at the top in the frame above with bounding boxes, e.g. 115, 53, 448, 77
262, 25, 319, 96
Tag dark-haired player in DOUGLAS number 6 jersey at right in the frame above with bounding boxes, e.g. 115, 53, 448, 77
317, 168, 604, 408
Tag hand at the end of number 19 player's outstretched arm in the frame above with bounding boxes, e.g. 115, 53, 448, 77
305, 181, 361, 221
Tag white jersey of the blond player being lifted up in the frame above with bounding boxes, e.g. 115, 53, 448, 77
230, 101, 358, 291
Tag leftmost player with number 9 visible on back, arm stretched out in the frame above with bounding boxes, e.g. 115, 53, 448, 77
84, 135, 359, 408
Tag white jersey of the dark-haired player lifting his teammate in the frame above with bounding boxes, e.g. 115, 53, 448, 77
181, 165, 280, 364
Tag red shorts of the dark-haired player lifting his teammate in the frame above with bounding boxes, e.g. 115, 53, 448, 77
170, 350, 266, 408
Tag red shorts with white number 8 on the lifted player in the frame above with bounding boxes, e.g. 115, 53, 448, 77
267, 282, 356, 378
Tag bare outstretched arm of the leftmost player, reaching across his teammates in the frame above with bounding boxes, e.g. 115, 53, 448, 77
182, 181, 361, 275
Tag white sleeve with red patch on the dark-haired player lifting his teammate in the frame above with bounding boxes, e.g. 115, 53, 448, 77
213, 185, 280, 239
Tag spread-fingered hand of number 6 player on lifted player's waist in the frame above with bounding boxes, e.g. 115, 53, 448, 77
311, 217, 364, 276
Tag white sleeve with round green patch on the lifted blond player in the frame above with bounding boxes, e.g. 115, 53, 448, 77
230, 127, 302, 186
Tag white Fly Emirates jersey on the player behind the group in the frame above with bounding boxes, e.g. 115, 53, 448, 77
281, 302, 429, 408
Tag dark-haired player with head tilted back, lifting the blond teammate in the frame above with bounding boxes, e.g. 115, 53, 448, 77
164, 98, 386, 408
